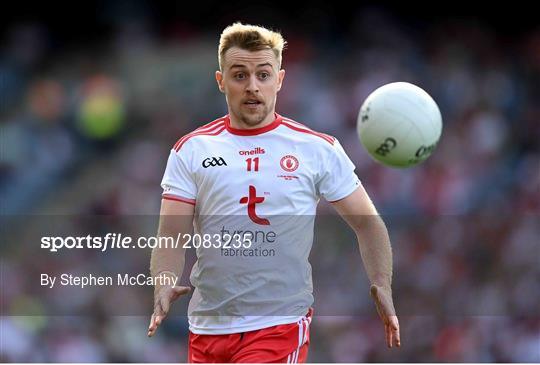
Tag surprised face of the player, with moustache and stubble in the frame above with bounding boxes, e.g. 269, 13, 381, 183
216, 47, 285, 127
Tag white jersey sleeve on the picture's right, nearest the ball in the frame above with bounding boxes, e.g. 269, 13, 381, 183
317, 139, 360, 202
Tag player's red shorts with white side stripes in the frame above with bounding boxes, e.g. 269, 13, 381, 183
188, 308, 313, 363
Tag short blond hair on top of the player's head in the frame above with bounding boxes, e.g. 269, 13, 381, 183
218, 22, 287, 70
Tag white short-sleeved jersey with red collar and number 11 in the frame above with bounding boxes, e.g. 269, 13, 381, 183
162, 114, 360, 334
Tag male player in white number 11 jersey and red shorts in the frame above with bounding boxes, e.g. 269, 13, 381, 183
148, 23, 400, 363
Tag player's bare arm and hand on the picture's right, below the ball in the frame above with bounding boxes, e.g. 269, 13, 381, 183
332, 185, 401, 347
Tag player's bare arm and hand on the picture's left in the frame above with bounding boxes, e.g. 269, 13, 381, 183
148, 199, 195, 337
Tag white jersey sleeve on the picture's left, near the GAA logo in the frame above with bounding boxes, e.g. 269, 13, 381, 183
161, 148, 197, 204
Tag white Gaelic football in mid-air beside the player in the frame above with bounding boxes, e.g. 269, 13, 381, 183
357, 82, 442, 168
